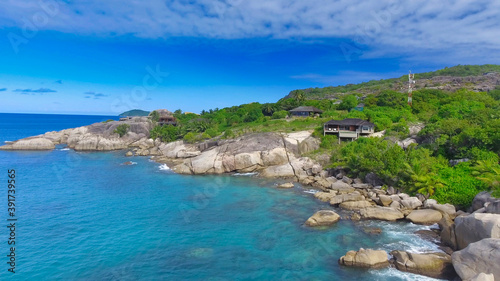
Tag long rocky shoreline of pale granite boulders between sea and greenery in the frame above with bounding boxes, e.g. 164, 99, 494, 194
0, 117, 500, 280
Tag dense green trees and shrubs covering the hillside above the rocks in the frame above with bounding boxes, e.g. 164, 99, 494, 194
146, 65, 500, 207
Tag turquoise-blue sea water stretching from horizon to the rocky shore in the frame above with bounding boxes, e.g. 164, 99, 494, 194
0, 114, 442, 281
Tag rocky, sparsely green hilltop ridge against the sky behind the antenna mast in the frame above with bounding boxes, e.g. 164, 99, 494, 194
283, 64, 500, 99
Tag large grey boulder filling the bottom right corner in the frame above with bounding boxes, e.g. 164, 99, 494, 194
451, 238, 500, 280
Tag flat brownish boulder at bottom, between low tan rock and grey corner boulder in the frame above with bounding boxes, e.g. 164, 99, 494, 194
391, 251, 456, 280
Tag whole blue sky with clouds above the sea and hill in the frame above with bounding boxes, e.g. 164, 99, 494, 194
0, 0, 500, 115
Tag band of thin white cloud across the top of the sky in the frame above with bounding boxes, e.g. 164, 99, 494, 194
0, 0, 500, 63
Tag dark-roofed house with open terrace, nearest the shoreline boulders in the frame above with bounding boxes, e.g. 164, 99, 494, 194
323, 118, 375, 141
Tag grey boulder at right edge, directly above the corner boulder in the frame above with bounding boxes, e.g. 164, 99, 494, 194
455, 213, 500, 249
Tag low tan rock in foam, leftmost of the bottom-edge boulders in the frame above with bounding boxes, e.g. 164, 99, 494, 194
339, 248, 389, 268
